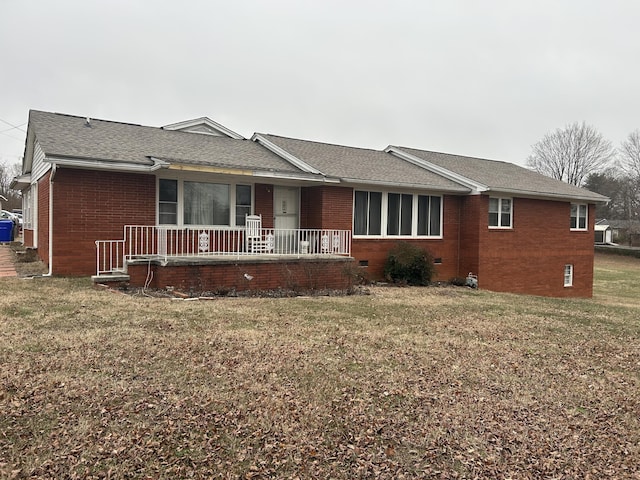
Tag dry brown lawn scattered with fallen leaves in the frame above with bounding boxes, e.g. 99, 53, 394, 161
0, 256, 640, 479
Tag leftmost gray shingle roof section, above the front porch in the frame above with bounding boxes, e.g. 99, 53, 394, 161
29, 110, 300, 173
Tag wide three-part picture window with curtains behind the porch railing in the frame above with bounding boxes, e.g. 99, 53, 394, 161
158, 178, 253, 226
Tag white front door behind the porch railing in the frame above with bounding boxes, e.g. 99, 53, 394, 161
273, 186, 300, 253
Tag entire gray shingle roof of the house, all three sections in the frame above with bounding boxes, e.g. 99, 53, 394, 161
29, 110, 607, 202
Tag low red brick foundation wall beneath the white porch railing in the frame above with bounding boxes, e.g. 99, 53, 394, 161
128, 258, 351, 293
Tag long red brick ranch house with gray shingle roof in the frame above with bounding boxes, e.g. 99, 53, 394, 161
13, 110, 607, 297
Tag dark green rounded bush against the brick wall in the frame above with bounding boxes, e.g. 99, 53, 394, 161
384, 242, 435, 285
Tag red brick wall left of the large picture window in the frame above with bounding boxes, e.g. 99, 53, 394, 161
51, 168, 156, 276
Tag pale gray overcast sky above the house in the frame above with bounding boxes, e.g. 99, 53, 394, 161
0, 0, 640, 170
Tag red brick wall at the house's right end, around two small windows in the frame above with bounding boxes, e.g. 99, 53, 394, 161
461, 195, 595, 297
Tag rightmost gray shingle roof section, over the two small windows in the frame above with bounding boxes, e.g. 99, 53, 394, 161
395, 147, 608, 202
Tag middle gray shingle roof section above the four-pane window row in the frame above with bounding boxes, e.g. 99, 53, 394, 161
260, 134, 469, 193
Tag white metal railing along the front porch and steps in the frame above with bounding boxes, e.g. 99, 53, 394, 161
96, 225, 351, 275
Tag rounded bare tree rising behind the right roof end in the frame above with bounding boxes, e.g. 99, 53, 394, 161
527, 122, 615, 186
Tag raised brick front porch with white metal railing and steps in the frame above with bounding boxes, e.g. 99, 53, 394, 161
92, 223, 353, 292
